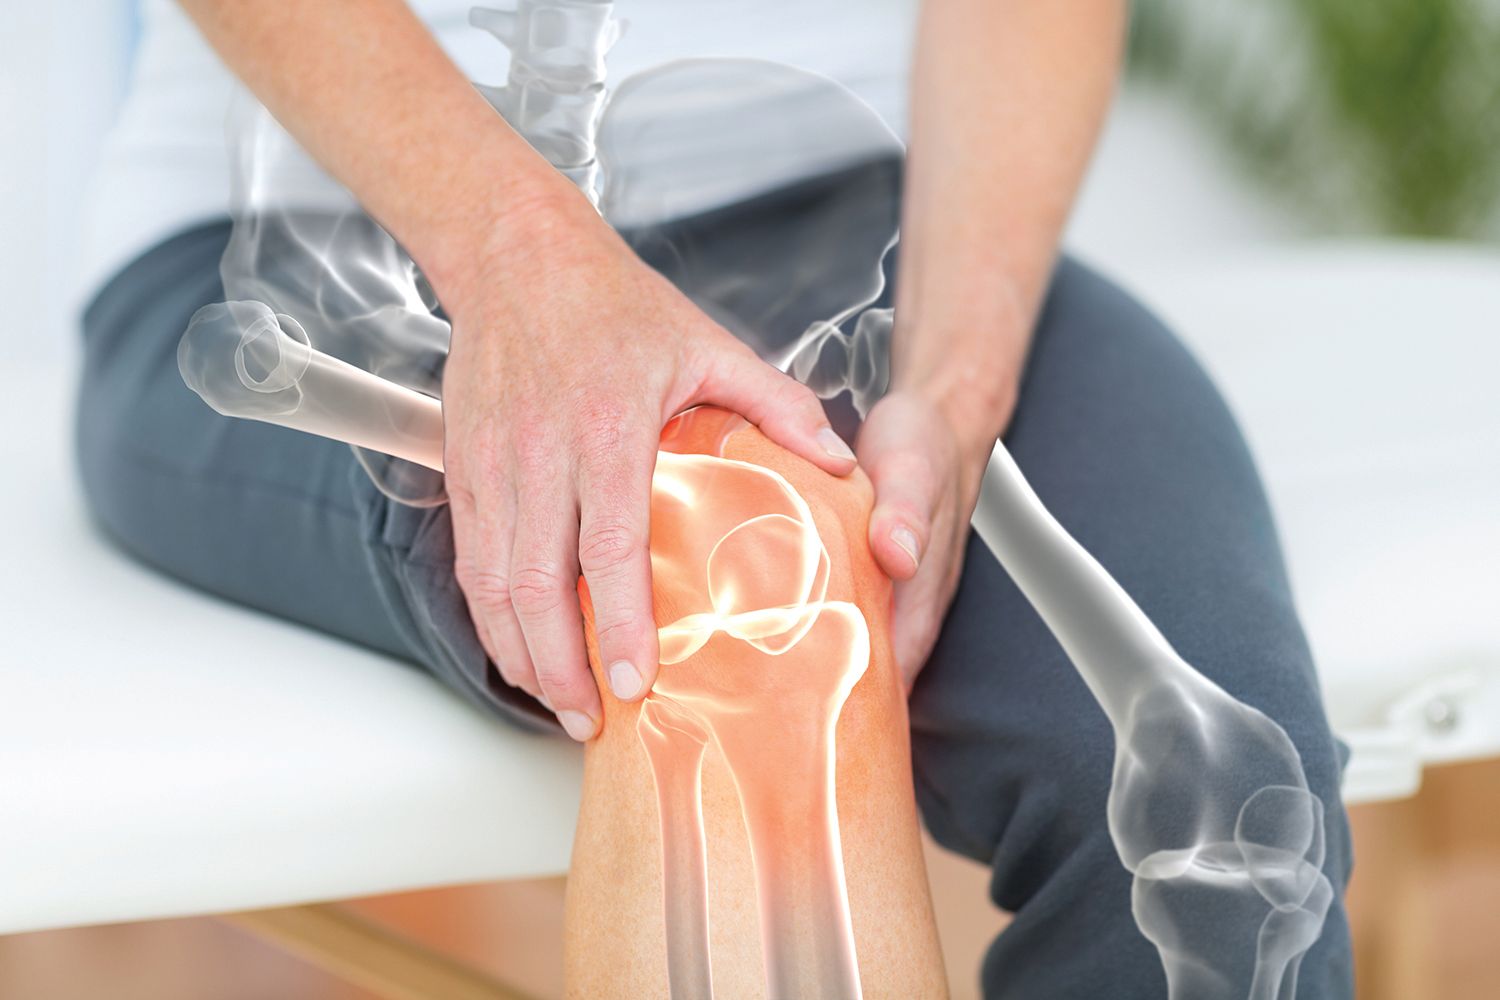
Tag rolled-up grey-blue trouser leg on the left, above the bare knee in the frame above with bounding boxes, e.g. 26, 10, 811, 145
77, 222, 560, 732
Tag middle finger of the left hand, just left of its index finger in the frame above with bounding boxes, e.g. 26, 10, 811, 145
509, 442, 602, 742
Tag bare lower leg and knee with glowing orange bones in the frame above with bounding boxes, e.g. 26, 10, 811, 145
569, 411, 945, 997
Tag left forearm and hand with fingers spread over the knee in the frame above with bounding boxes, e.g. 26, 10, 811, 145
183, 0, 855, 739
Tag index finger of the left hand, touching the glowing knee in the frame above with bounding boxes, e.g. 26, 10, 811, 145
578, 422, 659, 702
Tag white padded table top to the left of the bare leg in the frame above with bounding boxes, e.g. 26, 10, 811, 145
0, 366, 582, 933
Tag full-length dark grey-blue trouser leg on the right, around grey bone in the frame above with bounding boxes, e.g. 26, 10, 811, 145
912, 261, 1353, 1000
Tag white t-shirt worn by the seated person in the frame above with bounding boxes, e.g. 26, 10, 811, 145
80, 0, 915, 296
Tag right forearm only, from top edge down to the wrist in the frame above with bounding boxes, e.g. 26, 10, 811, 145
893, 0, 1128, 454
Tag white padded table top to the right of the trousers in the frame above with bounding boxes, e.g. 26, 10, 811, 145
1127, 243, 1500, 801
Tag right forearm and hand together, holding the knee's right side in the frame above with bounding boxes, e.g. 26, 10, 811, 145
857, 0, 1128, 687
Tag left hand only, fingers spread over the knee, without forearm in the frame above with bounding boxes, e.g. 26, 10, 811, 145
440, 193, 855, 741
